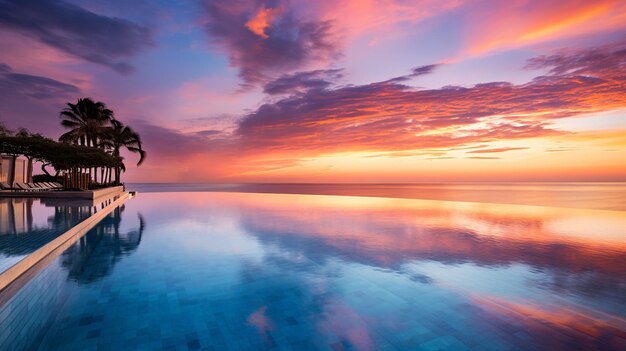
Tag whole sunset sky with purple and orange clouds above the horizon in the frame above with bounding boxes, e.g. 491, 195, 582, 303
0, 0, 626, 183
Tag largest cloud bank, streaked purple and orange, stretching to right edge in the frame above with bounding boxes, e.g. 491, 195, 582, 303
236, 42, 626, 155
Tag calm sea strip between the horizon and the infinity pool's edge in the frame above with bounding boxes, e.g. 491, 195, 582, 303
128, 183, 626, 211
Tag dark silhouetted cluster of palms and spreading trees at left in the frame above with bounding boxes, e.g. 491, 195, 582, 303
0, 98, 146, 189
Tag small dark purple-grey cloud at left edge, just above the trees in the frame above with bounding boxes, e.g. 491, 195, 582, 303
0, 63, 80, 99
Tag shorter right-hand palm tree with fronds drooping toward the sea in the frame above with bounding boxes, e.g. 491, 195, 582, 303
99, 119, 146, 184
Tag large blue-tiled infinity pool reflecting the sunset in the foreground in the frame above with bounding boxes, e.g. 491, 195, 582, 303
0, 193, 626, 350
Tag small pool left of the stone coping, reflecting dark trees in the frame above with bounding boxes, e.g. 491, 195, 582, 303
0, 198, 98, 273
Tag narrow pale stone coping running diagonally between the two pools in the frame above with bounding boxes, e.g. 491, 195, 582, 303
0, 193, 132, 293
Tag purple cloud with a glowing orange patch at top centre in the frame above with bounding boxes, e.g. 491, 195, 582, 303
203, 0, 339, 87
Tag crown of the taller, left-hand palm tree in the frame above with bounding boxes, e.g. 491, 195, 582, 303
59, 98, 113, 147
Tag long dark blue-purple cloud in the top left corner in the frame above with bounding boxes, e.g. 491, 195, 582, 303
0, 0, 152, 74
